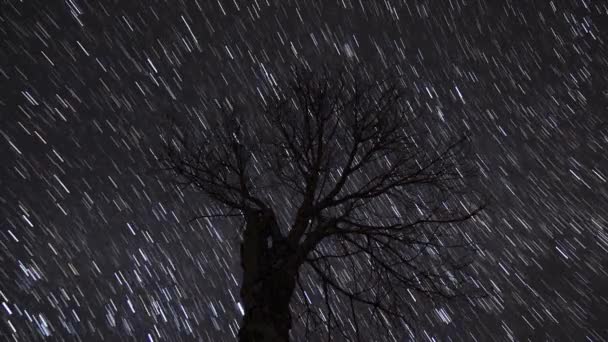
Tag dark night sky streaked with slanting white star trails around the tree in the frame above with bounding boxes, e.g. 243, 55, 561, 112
0, 0, 608, 341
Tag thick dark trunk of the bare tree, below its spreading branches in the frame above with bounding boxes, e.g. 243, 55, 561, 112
239, 208, 298, 342
